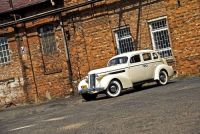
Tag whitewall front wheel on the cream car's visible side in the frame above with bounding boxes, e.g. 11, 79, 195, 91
106, 80, 122, 97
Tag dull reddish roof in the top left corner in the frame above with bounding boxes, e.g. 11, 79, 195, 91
0, 0, 48, 13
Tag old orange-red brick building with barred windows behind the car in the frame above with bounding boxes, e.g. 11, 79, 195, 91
0, 0, 200, 105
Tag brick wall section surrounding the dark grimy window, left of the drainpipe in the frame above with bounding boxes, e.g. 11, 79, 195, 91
22, 17, 71, 100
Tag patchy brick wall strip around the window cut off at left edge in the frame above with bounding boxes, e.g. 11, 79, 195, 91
0, 28, 25, 106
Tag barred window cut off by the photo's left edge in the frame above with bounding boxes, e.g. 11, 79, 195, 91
0, 37, 10, 64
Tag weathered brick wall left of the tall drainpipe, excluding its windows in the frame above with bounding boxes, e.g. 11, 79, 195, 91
0, 16, 72, 105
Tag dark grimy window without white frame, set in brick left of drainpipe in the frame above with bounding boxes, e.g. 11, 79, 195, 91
38, 25, 57, 54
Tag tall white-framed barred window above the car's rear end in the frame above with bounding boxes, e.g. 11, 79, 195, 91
149, 17, 172, 58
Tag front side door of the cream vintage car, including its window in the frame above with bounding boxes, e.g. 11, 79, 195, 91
129, 54, 146, 83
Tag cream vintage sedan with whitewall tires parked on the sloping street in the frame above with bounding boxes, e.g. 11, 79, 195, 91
78, 50, 174, 101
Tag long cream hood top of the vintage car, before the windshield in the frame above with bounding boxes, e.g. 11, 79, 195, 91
88, 64, 127, 75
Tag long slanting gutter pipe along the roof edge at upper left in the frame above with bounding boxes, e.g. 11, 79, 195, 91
0, 0, 103, 28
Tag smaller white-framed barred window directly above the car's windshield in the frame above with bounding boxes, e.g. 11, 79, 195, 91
115, 27, 135, 53
